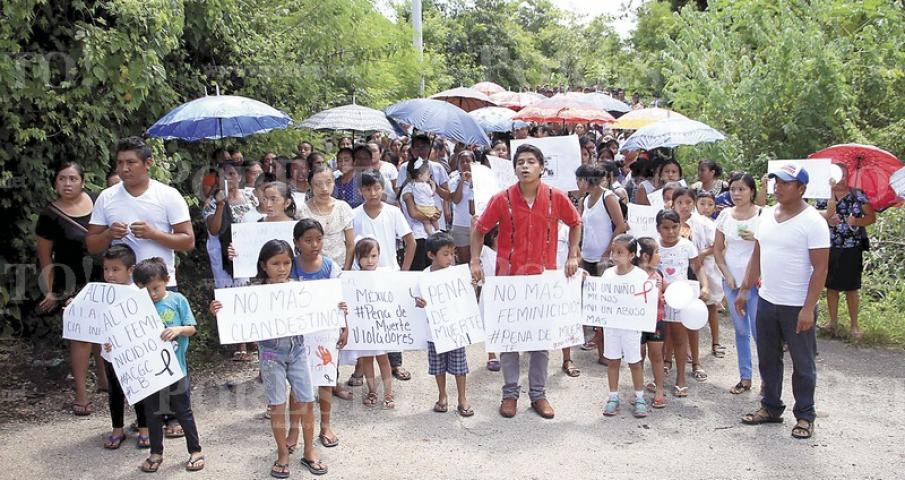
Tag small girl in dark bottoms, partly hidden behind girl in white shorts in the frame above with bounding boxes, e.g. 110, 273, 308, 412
638, 237, 666, 408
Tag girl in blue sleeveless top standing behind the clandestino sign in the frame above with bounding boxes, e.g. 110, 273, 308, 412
289, 218, 352, 452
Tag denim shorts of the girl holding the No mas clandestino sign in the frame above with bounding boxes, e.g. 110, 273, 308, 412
258, 335, 314, 405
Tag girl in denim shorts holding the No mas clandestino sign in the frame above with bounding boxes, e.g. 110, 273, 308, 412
210, 240, 327, 478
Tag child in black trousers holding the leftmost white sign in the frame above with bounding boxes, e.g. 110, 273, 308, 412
97, 248, 151, 450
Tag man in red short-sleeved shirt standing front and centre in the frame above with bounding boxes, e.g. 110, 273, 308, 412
470, 144, 581, 418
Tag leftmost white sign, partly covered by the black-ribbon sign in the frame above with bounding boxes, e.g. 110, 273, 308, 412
63, 282, 136, 343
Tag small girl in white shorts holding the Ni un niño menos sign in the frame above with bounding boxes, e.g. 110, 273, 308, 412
601, 233, 648, 418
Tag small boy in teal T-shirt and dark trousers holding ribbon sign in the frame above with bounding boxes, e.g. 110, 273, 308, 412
132, 257, 204, 473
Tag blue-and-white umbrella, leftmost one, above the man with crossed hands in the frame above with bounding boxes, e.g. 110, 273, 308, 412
148, 95, 292, 142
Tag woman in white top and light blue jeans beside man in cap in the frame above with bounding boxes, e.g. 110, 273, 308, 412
713, 173, 760, 394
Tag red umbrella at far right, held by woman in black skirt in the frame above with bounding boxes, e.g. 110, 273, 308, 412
808, 143, 902, 212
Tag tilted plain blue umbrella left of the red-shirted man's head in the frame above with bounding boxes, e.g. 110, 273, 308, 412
384, 98, 490, 147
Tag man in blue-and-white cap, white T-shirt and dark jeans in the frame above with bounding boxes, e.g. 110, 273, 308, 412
735, 164, 830, 438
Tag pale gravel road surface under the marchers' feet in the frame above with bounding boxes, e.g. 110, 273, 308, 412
0, 319, 905, 479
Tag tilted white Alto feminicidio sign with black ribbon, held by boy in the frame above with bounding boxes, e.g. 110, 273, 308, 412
104, 290, 185, 405
